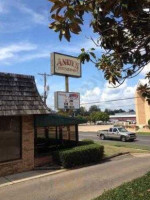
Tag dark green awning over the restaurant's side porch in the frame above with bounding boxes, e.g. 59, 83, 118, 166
35, 114, 86, 127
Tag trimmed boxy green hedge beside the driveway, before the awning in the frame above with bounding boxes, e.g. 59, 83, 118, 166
53, 144, 104, 168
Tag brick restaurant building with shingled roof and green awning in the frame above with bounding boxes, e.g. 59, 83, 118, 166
0, 73, 80, 176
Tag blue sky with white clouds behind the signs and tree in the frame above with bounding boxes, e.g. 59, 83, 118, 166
0, 0, 150, 110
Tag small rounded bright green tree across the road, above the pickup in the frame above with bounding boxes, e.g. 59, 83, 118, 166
90, 112, 109, 123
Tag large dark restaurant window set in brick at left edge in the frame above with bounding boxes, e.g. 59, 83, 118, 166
0, 117, 21, 162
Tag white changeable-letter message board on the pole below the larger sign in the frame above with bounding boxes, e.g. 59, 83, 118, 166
55, 92, 80, 110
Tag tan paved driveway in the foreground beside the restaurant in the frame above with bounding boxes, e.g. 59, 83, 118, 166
0, 156, 150, 200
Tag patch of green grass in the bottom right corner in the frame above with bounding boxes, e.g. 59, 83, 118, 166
95, 173, 150, 200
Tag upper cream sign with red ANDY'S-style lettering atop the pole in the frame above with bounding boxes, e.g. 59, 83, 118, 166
51, 53, 81, 78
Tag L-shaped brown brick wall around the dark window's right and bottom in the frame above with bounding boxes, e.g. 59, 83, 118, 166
0, 116, 34, 176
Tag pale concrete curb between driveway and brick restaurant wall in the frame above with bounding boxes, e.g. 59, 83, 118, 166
0, 169, 68, 188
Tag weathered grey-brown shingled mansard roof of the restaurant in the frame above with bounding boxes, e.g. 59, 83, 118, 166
0, 73, 50, 116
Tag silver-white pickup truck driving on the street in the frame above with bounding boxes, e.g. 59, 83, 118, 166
97, 127, 136, 142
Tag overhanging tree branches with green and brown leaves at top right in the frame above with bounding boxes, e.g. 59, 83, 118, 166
49, 0, 150, 87
